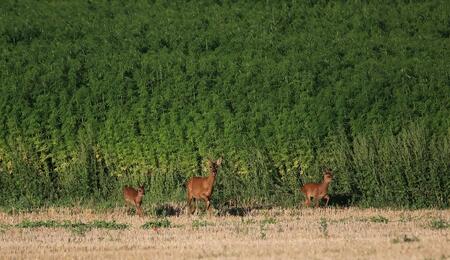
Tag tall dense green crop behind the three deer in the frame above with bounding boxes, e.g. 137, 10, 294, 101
0, 0, 450, 207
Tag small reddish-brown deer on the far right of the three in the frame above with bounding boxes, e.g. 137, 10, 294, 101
301, 169, 333, 208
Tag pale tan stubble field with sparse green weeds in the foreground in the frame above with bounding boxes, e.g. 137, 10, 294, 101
0, 208, 450, 259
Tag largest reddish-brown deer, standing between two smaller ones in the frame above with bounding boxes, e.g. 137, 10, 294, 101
186, 158, 222, 216
